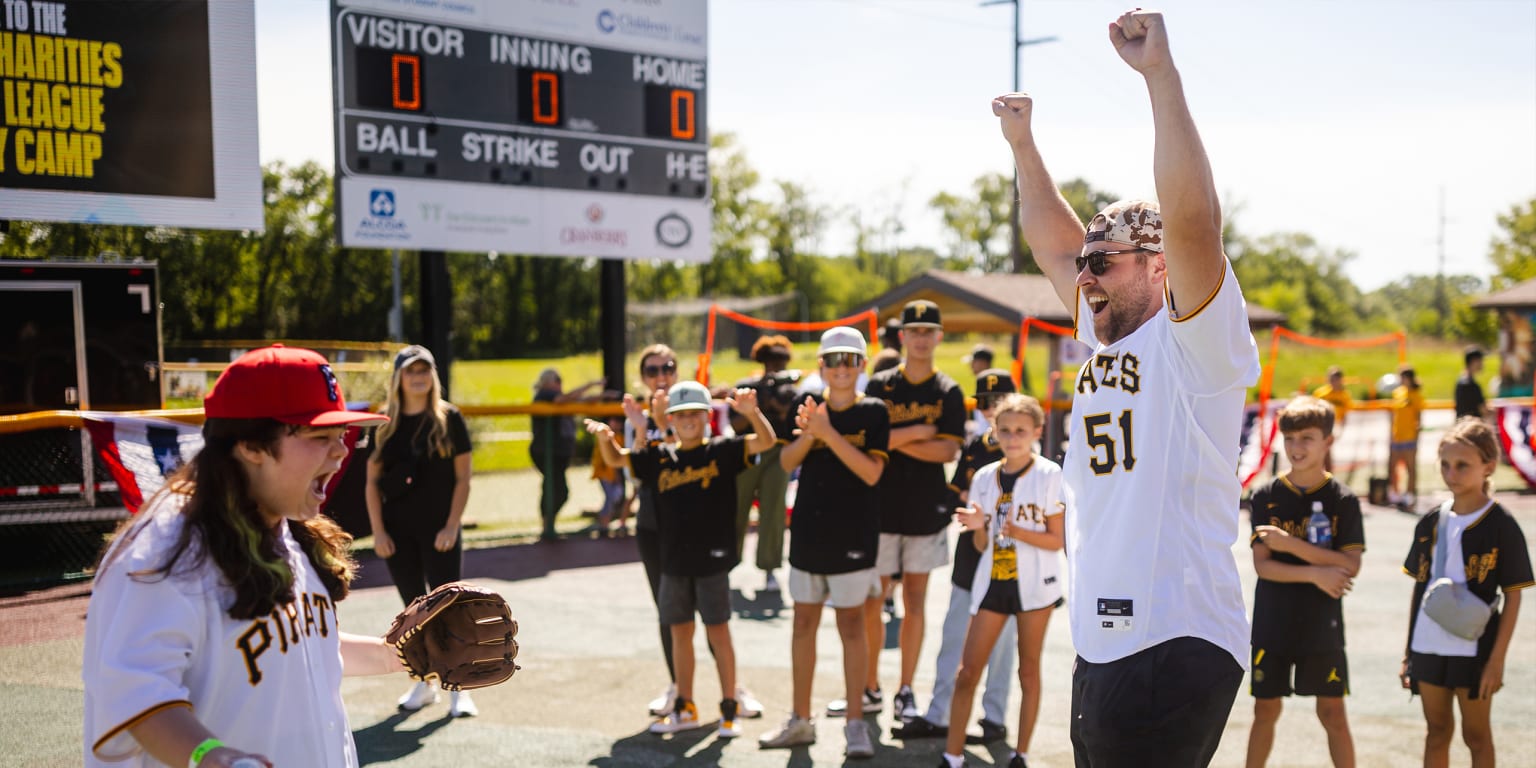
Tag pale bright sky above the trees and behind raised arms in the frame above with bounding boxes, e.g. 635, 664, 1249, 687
257, 0, 1536, 289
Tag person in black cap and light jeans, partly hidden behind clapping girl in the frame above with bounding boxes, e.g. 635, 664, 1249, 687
891, 369, 1015, 742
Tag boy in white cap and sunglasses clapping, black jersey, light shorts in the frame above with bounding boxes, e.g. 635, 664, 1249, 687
757, 327, 891, 757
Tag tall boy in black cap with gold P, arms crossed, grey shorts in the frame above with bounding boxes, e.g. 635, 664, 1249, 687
866, 301, 966, 722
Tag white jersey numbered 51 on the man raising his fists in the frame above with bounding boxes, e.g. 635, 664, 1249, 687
1063, 264, 1260, 667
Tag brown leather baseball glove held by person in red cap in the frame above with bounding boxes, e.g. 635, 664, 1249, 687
384, 581, 519, 691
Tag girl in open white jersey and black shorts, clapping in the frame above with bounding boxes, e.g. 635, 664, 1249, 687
945, 395, 1066, 768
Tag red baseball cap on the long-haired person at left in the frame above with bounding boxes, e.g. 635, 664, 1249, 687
203, 344, 389, 427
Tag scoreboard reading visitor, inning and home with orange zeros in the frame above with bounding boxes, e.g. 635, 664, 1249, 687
332, 0, 710, 261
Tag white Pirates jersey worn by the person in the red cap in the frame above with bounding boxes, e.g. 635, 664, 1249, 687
81, 495, 358, 768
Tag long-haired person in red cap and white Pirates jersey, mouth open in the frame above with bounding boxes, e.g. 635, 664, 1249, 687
81, 346, 401, 768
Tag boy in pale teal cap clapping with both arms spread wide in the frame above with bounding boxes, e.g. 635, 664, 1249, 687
587, 381, 774, 737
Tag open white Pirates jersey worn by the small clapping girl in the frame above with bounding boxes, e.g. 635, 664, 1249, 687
962, 456, 1066, 616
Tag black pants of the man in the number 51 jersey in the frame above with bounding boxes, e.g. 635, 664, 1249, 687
1072, 637, 1243, 768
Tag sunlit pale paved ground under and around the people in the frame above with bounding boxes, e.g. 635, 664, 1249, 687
0, 417, 1536, 768
